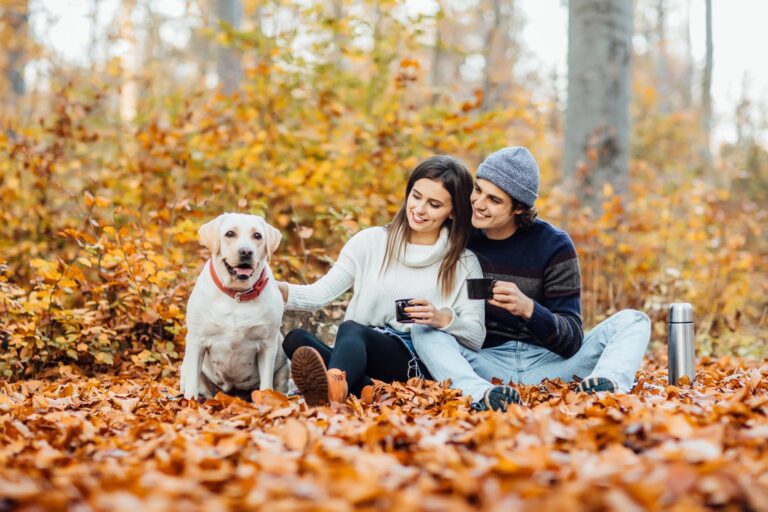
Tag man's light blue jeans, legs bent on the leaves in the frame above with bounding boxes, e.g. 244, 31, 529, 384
411, 309, 651, 401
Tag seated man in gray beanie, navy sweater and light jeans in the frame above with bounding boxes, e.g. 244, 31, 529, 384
411, 147, 651, 410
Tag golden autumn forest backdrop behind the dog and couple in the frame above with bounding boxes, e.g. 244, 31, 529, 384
0, 0, 768, 380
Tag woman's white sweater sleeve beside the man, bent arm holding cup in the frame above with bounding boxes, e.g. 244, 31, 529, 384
441, 254, 485, 351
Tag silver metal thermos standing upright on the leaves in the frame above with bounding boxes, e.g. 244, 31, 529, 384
667, 302, 696, 385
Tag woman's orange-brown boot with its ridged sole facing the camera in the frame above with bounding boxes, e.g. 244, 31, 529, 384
291, 347, 347, 407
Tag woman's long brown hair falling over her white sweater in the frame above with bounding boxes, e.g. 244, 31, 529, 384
381, 155, 473, 296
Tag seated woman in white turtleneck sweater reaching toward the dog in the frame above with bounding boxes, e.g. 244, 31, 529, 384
278, 156, 485, 405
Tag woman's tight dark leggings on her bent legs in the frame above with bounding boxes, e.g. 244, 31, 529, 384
283, 320, 412, 396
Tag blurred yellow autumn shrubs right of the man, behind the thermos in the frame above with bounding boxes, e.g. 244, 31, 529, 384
552, 162, 768, 356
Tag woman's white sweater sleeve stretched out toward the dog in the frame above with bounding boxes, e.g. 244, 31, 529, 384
285, 234, 360, 311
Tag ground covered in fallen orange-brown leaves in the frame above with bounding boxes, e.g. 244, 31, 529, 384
0, 358, 768, 512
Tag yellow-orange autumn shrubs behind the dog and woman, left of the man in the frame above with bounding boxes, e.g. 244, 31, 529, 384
0, 61, 552, 377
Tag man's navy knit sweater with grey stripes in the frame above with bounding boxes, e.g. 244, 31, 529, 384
469, 219, 584, 358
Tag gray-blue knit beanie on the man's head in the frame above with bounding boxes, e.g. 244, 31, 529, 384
476, 146, 539, 206
